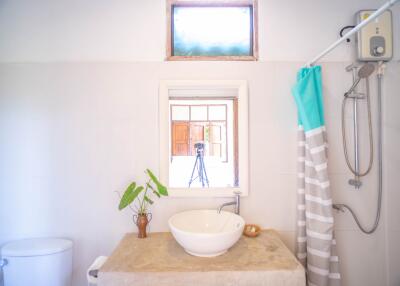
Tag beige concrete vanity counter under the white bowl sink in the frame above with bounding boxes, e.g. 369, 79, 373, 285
99, 230, 305, 286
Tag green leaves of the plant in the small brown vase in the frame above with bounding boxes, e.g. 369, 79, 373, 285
118, 169, 168, 215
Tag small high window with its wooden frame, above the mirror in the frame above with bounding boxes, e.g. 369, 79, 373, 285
167, 0, 258, 60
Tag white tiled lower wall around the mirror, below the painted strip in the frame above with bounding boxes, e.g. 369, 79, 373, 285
0, 62, 399, 286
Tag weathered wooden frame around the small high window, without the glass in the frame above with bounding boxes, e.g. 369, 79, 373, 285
166, 0, 258, 61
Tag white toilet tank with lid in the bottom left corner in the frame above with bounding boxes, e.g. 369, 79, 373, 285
1, 238, 72, 286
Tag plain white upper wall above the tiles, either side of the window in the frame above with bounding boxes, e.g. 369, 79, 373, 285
0, 0, 400, 62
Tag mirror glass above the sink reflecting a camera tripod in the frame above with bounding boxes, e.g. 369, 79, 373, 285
169, 97, 239, 188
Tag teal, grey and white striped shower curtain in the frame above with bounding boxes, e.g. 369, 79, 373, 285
292, 66, 340, 286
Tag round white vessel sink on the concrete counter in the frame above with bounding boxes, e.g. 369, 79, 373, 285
168, 210, 244, 257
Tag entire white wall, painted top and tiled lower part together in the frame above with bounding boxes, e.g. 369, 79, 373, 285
0, 0, 400, 286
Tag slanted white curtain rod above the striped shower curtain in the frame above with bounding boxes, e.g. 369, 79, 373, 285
306, 0, 400, 67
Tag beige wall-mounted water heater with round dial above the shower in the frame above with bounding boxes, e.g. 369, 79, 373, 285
356, 10, 393, 61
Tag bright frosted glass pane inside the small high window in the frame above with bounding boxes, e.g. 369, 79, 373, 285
173, 7, 252, 56
